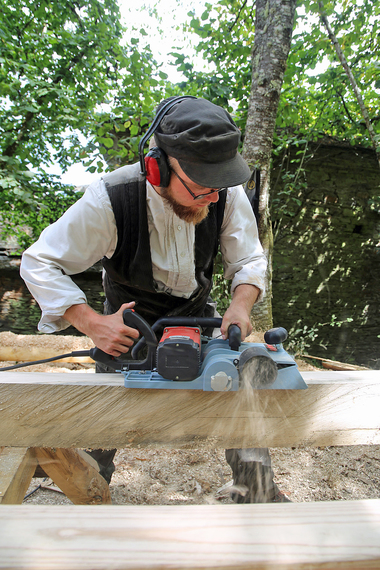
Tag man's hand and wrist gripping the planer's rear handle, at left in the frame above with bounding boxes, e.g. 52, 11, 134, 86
63, 301, 140, 356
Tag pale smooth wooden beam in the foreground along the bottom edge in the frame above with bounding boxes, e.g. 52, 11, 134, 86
0, 500, 380, 570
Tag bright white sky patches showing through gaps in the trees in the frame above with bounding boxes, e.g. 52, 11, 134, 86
54, 0, 206, 186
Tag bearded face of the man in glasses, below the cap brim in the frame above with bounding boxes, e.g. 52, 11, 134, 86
160, 159, 219, 225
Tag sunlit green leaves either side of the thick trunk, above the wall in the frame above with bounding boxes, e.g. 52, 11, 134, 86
175, 0, 380, 146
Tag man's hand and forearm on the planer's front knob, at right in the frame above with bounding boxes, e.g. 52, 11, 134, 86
220, 284, 260, 340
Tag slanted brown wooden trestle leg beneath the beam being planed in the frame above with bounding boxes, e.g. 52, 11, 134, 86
35, 448, 112, 505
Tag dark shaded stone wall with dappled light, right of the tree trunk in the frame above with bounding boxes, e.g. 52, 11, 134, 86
272, 143, 380, 368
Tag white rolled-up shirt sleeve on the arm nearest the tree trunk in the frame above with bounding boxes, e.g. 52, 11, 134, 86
220, 186, 267, 302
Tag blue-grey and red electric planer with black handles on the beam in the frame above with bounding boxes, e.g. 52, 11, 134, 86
89, 309, 307, 392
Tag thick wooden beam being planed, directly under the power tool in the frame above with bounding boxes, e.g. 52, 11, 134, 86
0, 371, 380, 448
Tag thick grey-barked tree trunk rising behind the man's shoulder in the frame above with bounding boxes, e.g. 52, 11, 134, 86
243, 0, 296, 330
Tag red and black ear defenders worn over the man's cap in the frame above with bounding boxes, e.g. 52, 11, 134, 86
139, 95, 197, 188
